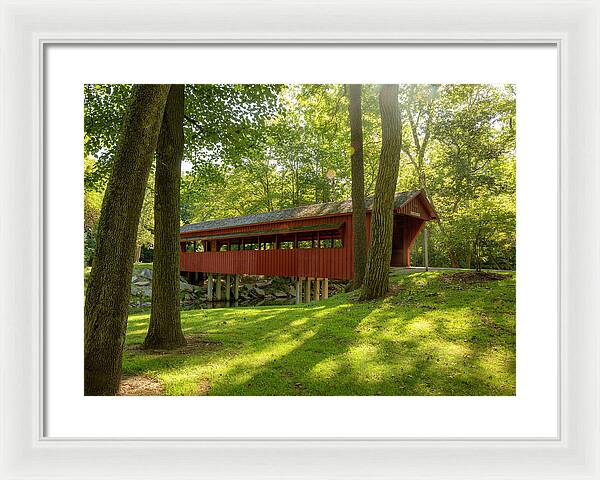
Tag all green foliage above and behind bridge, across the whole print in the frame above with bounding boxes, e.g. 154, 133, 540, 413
84, 84, 516, 269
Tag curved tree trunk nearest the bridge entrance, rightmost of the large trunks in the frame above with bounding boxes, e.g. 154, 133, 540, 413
361, 85, 402, 300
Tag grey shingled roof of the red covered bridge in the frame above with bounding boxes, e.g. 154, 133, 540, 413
181, 190, 434, 233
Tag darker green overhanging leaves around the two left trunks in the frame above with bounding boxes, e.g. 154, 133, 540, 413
84, 84, 282, 247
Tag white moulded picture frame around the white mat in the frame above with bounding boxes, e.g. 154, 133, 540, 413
0, 0, 600, 479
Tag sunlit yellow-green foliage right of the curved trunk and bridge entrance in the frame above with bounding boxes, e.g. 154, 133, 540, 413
399, 84, 516, 269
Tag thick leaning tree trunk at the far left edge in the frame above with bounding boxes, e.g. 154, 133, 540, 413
84, 85, 170, 395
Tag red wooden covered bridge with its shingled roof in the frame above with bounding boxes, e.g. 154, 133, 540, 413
181, 190, 437, 297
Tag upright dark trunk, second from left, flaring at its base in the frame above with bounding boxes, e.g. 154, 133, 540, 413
144, 85, 186, 349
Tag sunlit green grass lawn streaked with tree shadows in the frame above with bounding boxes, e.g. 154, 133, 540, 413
123, 271, 516, 395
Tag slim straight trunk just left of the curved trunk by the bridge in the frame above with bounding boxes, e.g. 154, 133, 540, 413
348, 85, 367, 289
